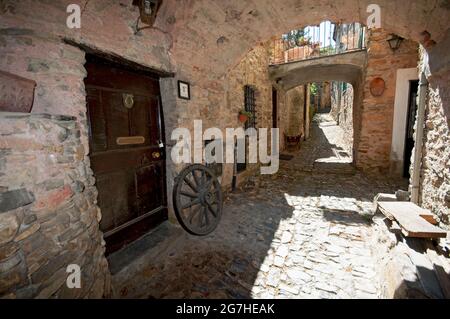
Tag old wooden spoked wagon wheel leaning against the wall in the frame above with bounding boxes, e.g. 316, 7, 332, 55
173, 164, 223, 236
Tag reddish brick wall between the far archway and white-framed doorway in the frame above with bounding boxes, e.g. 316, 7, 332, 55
356, 29, 419, 172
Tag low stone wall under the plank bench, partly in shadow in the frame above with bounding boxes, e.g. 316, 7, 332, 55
371, 213, 450, 299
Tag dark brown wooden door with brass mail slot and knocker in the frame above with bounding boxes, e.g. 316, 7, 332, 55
85, 56, 167, 254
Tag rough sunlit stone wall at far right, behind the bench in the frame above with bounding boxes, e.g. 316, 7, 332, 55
413, 32, 450, 230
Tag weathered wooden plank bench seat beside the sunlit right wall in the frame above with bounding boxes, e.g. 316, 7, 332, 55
378, 202, 447, 238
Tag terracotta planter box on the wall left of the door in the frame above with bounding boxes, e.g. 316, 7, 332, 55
0, 71, 36, 113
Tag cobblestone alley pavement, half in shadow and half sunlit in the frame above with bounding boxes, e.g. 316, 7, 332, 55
112, 118, 404, 298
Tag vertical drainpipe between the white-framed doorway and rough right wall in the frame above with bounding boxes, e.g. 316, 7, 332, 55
411, 72, 428, 205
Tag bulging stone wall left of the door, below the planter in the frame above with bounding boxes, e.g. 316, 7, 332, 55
0, 113, 110, 298
